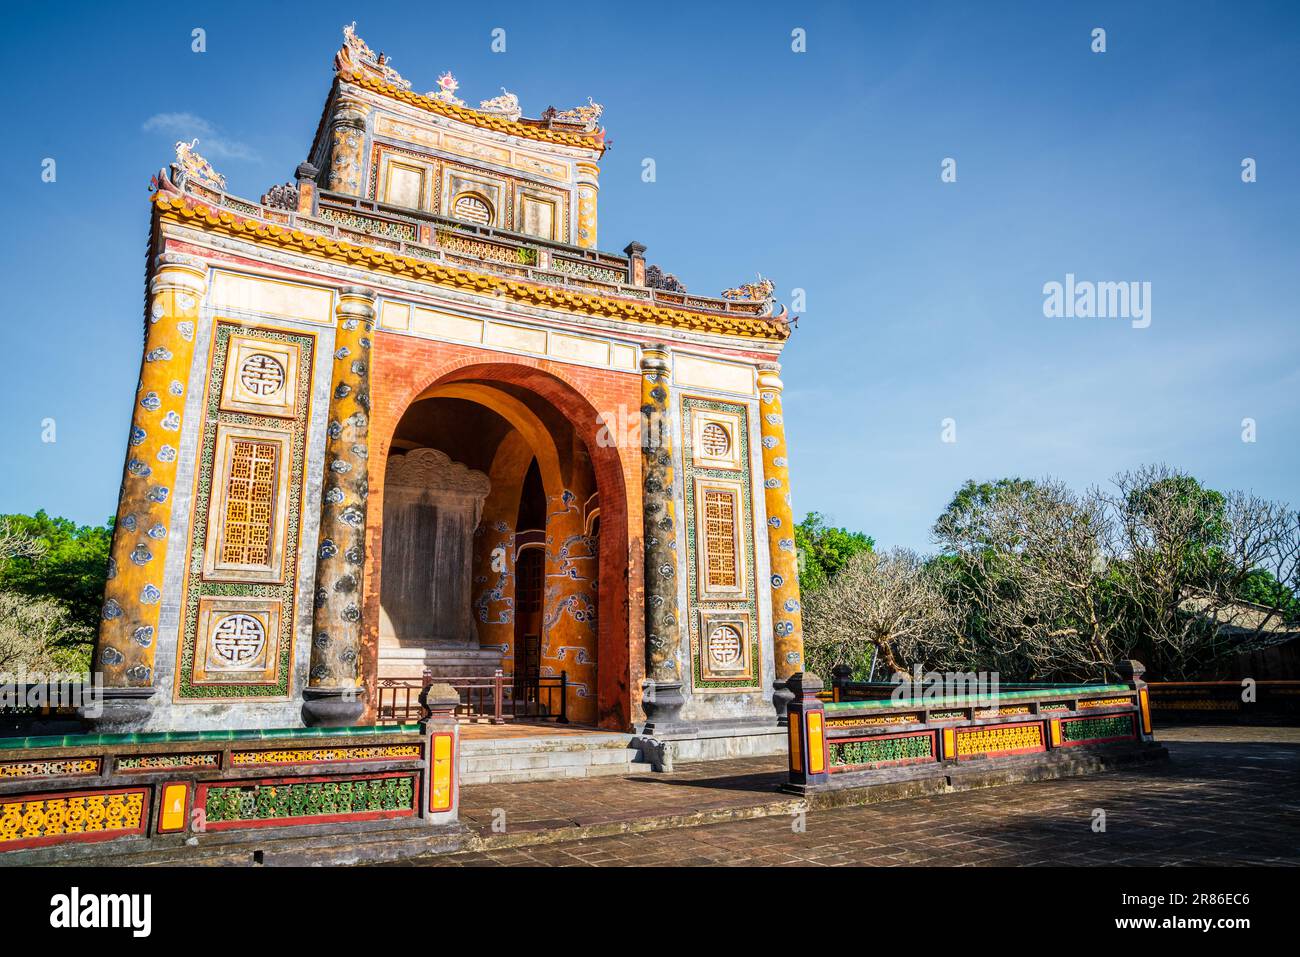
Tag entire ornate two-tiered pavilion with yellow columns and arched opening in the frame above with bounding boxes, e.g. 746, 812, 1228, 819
95, 27, 802, 748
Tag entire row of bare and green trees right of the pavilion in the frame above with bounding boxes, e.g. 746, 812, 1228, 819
800, 465, 1300, 681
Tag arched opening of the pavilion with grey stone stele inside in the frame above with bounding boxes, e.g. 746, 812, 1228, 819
365, 364, 641, 729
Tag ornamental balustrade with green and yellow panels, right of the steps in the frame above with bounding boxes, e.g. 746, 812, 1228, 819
787, 662, 1157, 793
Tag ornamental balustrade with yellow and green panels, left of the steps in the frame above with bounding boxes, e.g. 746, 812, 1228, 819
0, 685, 459, 861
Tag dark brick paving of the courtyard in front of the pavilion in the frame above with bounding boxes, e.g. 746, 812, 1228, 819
408, 726, 1300, 866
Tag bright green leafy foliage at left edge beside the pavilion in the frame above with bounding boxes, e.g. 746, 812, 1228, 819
0, 510, 113, 629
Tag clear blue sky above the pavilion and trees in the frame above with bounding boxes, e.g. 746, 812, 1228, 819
0, 1, 1300, 550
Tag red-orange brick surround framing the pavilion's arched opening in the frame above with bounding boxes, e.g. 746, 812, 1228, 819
361, 332, 644, 731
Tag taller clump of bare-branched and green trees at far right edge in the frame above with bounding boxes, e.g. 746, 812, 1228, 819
935, 465, 1300, 680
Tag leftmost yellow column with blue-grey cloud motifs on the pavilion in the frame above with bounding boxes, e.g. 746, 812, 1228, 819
94, 254, 208, 731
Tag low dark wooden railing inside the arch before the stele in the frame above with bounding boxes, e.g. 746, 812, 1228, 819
376, 671, 568, 724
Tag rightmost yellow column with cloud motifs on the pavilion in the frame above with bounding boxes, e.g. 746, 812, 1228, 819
758, 363, 803, 720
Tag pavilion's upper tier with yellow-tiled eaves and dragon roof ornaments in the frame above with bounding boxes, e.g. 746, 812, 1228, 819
152, 26, 792, 341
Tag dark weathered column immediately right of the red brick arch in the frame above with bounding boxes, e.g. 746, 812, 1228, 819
641, 346, 685, 735
